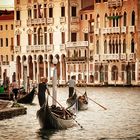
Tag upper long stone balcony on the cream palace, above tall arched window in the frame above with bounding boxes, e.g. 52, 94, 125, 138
27, 18, 46, 26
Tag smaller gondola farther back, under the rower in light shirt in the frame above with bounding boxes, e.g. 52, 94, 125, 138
66, 92, 88, 110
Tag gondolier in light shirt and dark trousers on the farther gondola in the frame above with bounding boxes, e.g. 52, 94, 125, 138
66, 76, 76, 97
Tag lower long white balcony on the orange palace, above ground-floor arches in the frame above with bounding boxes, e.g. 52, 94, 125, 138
101, 54, 119, 61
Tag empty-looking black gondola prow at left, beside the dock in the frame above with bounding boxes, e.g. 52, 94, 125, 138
17, 87, 36, 104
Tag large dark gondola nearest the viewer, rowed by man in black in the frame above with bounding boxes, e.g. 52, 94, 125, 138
37, 97, 75, 130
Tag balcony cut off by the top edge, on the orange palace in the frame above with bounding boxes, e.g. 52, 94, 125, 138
108, 0, 122, 8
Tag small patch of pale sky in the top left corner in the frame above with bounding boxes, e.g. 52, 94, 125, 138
0, 0, 14, 9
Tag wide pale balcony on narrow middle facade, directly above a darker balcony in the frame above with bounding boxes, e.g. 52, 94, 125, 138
66, 41, 88, 48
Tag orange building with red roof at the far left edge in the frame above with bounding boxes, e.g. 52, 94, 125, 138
0, 10, 15, 84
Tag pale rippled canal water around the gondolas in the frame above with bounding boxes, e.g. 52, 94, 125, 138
0, 87, 140, 140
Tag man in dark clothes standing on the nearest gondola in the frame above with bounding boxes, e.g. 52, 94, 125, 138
38, 77, 50, 107
